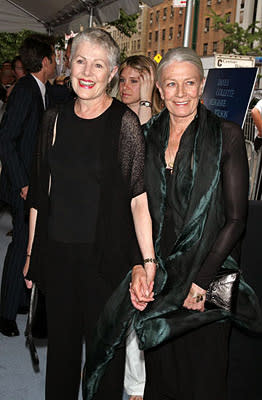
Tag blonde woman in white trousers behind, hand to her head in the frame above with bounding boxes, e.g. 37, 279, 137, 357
119, 55, 162, 400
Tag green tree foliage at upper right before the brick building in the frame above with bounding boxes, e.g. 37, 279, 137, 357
209, 10, 262, 56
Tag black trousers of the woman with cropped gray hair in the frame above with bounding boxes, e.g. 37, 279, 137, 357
46, 242, 125, 400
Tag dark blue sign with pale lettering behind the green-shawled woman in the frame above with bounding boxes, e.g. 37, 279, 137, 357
202, 68, 258, 127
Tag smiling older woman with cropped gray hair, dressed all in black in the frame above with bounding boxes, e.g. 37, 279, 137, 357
24, 29, 154, 400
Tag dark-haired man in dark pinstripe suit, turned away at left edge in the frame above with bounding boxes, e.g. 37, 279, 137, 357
0, 34, 56, 336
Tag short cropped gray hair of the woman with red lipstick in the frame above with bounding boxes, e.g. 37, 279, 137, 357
70, 28, 120, 71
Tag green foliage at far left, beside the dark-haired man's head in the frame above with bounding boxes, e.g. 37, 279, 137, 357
0, 30, 33, 65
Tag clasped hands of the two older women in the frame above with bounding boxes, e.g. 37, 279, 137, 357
129, 265, 155, 311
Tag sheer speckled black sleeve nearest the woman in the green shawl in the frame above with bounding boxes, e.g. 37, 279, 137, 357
119, 110, 145, 198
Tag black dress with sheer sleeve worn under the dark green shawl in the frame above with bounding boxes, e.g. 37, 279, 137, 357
144, 119, 248, 400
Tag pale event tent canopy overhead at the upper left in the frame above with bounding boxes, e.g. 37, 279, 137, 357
0, 0, 162, 33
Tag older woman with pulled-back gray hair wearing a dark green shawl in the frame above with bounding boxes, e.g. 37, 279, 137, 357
84, 48, 262, 400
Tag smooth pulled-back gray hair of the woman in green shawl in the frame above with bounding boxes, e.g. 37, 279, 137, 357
157, 47, 204, 81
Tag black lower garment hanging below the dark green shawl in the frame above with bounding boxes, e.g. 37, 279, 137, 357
144, 322, 230, 400
